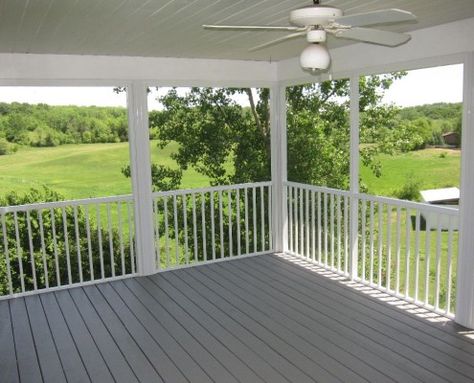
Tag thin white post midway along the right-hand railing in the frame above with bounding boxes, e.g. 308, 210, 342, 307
349, 75, 360, 279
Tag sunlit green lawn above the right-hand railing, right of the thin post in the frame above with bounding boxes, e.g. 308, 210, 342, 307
360, 149, 461, 196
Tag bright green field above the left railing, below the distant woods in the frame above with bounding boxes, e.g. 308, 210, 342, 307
0, 142, 209, 199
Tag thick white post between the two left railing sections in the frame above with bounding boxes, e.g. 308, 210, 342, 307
127, 82, 156, 275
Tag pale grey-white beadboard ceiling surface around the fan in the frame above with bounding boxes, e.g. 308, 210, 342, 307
0, 0, 474, 61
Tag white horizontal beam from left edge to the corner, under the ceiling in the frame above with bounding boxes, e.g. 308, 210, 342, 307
0, 53, 277, 87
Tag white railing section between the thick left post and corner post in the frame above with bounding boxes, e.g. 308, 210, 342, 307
153, 182, 273, 270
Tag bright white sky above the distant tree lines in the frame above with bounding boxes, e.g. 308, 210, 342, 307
0, 64, 463, 110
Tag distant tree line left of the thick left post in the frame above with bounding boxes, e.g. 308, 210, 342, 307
0, 102, 128, 154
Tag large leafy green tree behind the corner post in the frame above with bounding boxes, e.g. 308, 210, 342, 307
118, 73, 403, 266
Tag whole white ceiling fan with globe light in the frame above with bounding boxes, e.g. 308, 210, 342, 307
203, 0, 416, 72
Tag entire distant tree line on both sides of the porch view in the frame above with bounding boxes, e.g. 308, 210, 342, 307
0, 100, 462, 155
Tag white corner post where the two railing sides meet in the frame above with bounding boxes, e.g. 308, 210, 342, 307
270, 83, 288, 253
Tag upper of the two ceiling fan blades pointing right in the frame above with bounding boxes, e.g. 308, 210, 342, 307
334, 9, 416, 27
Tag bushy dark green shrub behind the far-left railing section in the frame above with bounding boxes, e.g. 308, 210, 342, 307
0, 187, 132, 296
